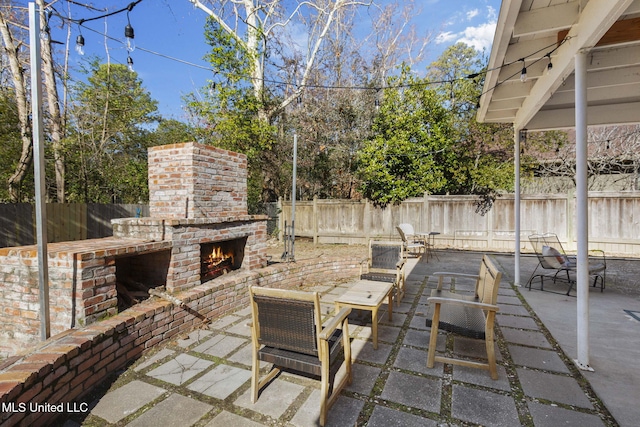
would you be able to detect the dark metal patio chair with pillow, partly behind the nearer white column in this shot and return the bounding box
[527,233,607,295]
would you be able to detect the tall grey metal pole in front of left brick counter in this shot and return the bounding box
[29,3,51,341]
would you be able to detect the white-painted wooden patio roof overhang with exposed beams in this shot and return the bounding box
[477,0,640,130]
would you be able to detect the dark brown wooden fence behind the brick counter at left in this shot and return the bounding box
[0,203,149,247]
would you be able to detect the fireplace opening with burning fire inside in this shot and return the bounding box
[200,237,247,283]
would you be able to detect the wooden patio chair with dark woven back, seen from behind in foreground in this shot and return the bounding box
[249,286,352,426]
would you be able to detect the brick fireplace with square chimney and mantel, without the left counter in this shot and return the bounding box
[112,142,267,292]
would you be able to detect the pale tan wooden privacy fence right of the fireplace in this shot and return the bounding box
[279,192,640,255]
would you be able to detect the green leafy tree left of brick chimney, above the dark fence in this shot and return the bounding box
[66,59,158,203]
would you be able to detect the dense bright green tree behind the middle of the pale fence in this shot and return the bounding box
[358,68,454,205]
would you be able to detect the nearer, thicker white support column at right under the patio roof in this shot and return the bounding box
[575,50,593,371]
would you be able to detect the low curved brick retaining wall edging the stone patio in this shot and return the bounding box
[0,258,360,426]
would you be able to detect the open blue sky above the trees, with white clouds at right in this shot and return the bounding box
[53,0,501,120]
